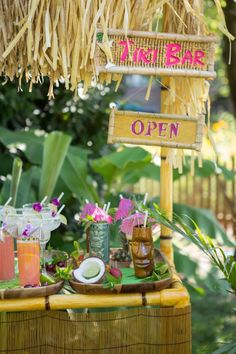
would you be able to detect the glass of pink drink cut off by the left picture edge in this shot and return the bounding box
[0,230,15,281]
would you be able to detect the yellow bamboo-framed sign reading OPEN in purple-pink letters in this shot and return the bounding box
[108,109,205,151]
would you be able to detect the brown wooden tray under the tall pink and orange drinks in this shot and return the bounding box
[0,280,64,301]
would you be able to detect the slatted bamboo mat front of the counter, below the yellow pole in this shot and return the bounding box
[0,306,191,354]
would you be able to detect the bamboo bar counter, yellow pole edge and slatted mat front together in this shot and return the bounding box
[0,268,192,354]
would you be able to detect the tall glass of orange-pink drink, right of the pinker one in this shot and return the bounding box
[17,238,40,286]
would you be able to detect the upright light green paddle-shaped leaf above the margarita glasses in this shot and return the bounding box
[39,132,71,199]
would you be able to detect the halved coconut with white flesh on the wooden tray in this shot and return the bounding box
[73,257,106,284]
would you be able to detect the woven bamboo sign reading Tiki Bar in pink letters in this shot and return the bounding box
[95,29,216,79]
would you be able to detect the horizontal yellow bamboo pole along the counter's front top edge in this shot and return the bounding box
[0,288,189,312]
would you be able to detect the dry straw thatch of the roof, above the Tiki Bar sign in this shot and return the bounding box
[0,0,233,98]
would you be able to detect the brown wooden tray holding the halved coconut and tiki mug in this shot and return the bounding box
[69,249,172,294]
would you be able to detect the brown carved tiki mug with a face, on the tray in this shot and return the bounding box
[131,227,154,278]
